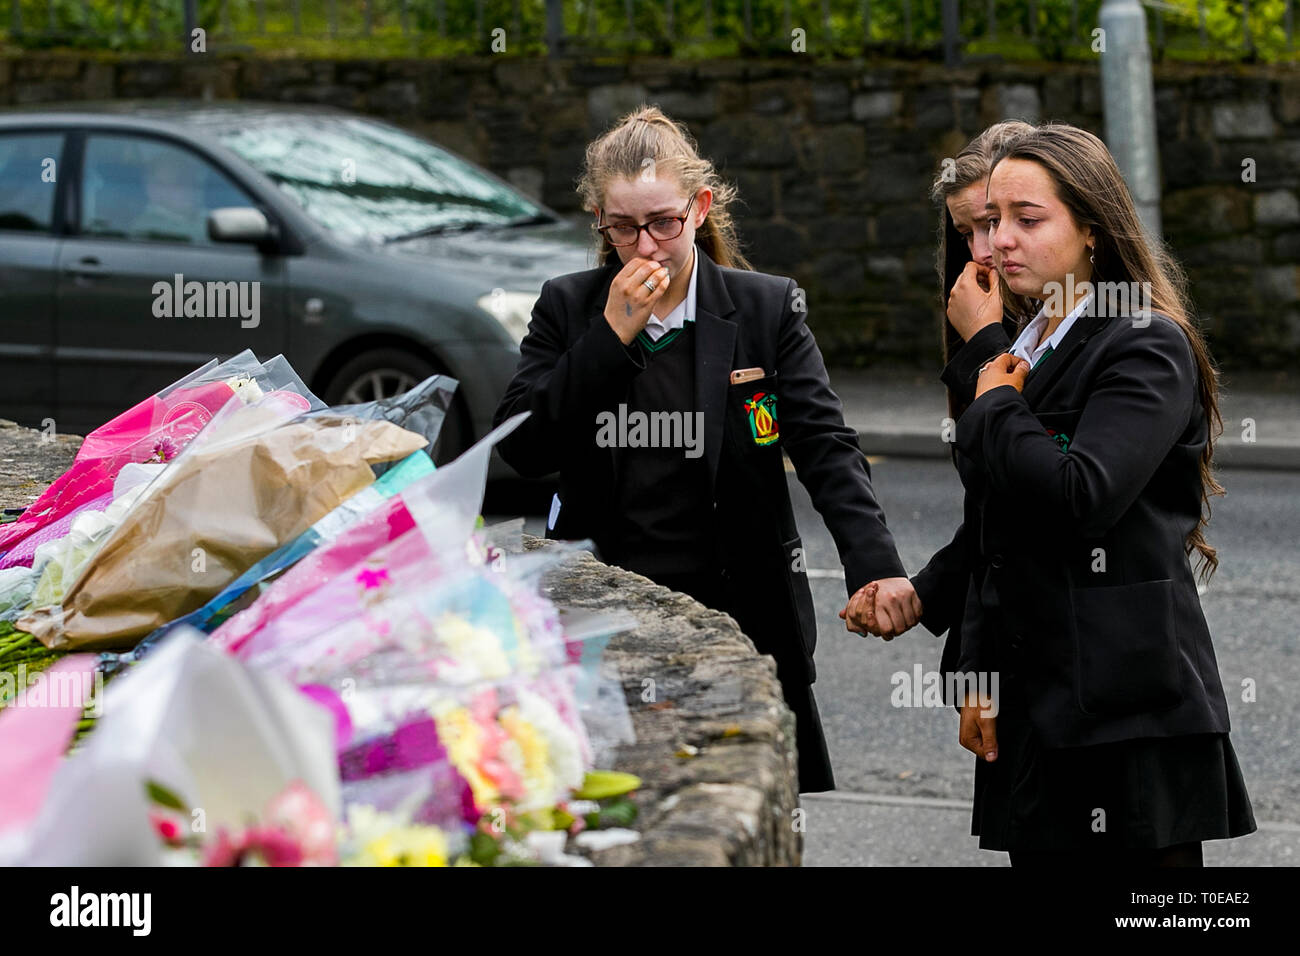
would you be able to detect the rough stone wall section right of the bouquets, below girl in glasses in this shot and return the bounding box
[525,536,803,866]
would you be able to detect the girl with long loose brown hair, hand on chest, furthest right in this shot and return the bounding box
[956,124,1256,865]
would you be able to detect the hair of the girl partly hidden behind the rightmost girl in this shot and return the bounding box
[930,120,1034,419]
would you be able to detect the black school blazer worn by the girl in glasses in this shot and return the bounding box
[494,243,904,682]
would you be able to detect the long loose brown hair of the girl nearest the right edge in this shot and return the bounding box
[989,124,1223,580]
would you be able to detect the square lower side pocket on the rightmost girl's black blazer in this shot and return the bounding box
[1070,580,1183,717]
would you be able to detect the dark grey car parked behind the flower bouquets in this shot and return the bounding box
[0,101,594,476]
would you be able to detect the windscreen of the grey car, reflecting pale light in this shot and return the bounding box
[209,116,550,242]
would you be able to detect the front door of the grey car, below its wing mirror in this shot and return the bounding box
[55,129,286,428]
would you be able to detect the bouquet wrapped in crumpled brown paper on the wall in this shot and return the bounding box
[18,392,425,650]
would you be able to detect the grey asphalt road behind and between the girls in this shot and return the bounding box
[489,458,1300,866]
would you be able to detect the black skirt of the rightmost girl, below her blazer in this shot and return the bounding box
[971,685,1256,853]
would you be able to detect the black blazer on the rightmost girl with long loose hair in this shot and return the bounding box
[919,306,1229,747]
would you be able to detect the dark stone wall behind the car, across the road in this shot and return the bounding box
[0,55,1300,368]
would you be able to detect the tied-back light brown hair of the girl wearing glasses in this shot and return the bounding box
[577,105,754,269]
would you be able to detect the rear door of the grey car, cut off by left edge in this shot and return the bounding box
[0,130,65,427]
